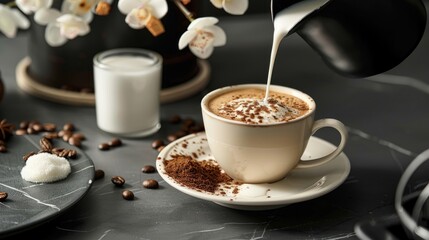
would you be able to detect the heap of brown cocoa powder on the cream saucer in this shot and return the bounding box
[164,155,233,193]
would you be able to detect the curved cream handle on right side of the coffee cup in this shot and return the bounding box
[296,118,348,168]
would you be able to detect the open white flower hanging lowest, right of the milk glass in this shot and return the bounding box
[179,17,226,59]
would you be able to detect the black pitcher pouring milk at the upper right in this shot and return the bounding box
[272,0,427,77]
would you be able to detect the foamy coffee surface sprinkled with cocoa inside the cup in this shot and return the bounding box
[209,89,308,124]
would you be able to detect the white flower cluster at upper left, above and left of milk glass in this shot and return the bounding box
[34,8,90,47]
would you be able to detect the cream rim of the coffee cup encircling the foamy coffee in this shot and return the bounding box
[201,83,316,127]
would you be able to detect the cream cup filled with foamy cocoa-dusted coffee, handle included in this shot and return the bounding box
[201,84,347,183]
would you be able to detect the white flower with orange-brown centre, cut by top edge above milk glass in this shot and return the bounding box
[118,0,168,29]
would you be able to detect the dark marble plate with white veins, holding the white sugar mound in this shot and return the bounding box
[0,135,94,237]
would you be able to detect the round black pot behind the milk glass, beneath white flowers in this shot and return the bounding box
[27,1,199,91]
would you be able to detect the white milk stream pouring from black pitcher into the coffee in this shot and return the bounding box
[264,0,330,103]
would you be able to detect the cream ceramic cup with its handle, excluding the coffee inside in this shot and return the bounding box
[201,84,348,183]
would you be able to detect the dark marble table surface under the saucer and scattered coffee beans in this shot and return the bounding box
[0,5,429,239]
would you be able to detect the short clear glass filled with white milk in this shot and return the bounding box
[93,48,162,137]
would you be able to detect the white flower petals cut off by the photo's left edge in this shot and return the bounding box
[0,4,30,38]
